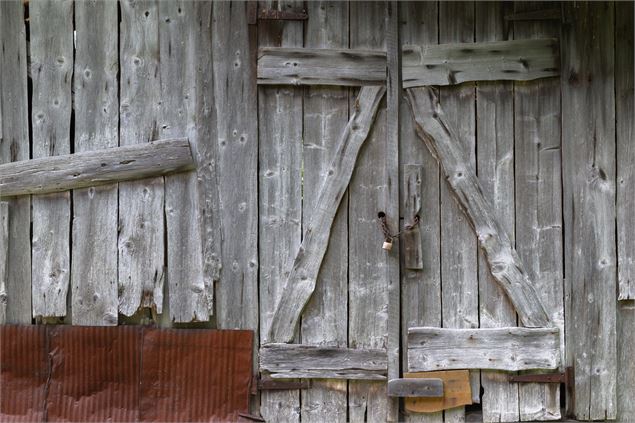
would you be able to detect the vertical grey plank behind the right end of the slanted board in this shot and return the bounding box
[159,2,216,322]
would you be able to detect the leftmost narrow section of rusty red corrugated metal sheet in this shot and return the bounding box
[0,326,49,422]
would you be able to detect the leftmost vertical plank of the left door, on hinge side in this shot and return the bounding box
[258,2,303,422]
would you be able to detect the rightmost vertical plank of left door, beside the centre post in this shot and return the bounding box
[348,2,390,422]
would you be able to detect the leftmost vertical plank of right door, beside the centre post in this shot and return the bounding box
[399,2,443,423]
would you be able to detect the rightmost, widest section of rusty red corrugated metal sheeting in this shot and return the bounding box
[140,329,253,421]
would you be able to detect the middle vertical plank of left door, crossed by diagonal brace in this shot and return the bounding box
[301,1,349,422]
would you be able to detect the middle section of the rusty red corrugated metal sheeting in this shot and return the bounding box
[47,326,142,422]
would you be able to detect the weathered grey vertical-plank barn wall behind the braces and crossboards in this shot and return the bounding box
[0,0,635,422]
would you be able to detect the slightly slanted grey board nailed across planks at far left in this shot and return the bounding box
[0,139,194,197]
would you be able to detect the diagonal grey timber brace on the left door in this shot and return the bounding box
[269,86,386,342]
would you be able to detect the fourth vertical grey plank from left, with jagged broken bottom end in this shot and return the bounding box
[118,0,165,316]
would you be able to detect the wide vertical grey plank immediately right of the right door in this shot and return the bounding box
[561,3,617,420]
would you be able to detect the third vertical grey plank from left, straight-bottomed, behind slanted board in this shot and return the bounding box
[72,1,119,326]
